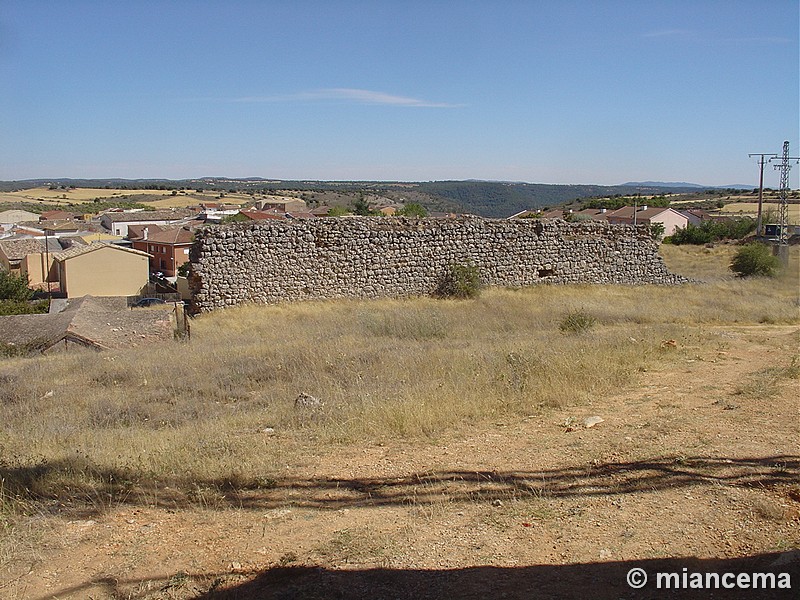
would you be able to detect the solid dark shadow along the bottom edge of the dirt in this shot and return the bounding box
[28,550,800,600]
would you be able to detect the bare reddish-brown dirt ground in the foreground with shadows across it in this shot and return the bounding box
[0,325,800,600]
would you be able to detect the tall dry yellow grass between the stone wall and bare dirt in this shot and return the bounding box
[0,248,799,525]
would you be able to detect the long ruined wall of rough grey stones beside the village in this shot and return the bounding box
[190,217,685,311]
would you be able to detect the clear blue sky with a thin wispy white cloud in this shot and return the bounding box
[0,0,800,187]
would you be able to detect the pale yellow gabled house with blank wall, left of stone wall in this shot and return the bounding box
[53,243,150,298]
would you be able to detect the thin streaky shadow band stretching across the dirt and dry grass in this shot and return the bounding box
[0,455,800,518]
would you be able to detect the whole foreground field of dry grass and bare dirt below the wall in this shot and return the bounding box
[0,246,800,599]
